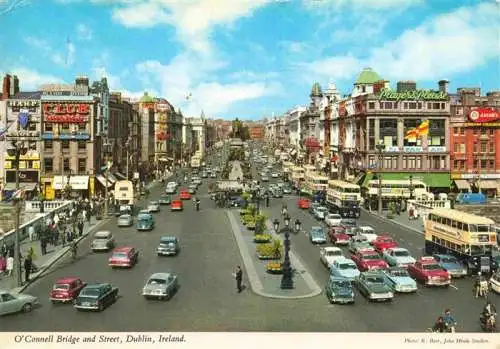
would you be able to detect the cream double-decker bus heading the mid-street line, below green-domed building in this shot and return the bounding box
[326,180,361,218]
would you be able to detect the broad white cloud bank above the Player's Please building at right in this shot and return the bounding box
[302,3,500,80]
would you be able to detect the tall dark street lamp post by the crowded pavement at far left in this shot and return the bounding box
[7,142,28,286]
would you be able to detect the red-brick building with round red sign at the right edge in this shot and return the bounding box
[450,88,500,196]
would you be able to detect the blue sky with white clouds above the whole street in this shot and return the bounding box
[0,0,500,119]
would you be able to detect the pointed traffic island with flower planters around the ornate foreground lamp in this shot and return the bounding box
[226,210,321,299]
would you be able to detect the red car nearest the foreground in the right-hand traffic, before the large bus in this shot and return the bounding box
[408,257,451,286]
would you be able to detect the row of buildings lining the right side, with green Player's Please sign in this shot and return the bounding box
[265,68,500,196]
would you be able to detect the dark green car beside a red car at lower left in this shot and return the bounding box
[73,283,118,311]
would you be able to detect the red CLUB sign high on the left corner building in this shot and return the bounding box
[43,103,90,124]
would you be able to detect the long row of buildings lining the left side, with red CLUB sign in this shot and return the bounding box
[0,75,215,200]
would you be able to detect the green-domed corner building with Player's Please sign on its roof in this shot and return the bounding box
[339,70,450,191]
